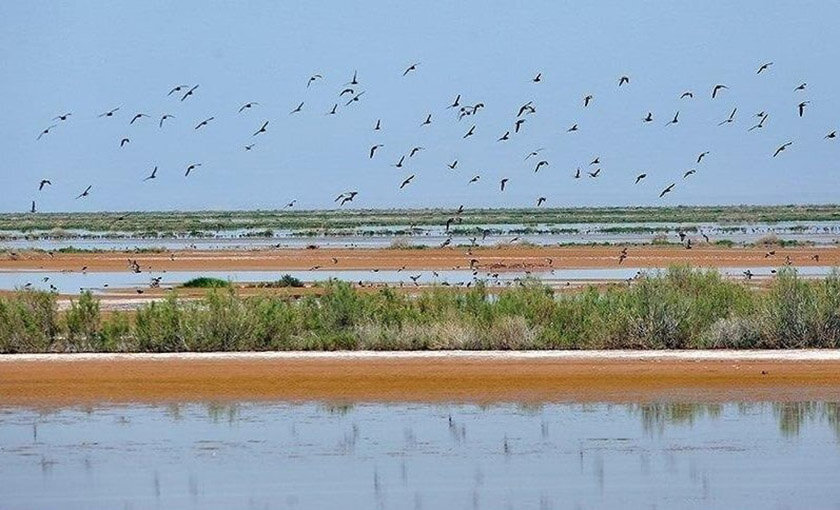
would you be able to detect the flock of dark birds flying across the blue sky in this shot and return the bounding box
[24,62,837,221]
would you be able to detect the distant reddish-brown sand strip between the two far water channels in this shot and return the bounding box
[0,245,840,272]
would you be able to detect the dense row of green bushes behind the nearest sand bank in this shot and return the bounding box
[0,267,840,353]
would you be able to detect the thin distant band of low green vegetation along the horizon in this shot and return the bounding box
[0,205,840,238]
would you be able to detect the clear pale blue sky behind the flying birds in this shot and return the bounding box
[0,0,840,212]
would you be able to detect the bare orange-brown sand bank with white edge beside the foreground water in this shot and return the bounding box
[0,350,840,407]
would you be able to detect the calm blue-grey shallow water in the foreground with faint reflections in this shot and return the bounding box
[0,403,840,509]
